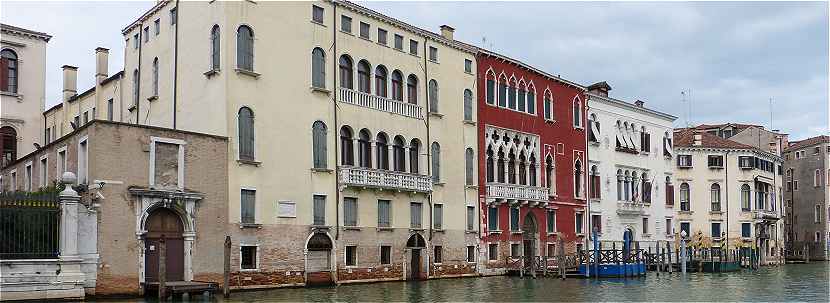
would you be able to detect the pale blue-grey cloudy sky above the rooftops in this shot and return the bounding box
[0,1,830,140]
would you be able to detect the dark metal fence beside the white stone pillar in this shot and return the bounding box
[0,192,61,260]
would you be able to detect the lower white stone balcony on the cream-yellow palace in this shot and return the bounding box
[337,166,432,192]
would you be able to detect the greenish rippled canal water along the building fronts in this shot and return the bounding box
[127,262,830,302]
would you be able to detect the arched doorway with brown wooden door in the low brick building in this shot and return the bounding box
[144,207,184,283]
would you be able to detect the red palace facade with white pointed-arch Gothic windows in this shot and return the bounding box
[477,51,588,273]
